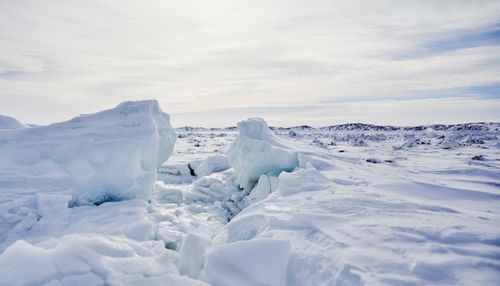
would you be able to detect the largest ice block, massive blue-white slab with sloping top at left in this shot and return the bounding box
[0,101,176,206]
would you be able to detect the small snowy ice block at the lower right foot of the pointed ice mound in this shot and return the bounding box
[278,167,332,196]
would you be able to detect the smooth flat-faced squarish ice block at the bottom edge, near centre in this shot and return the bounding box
[205,239,291,286]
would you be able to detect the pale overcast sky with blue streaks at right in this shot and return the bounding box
[0,0,500,127]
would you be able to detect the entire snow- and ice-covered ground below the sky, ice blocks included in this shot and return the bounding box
[0,102,500,285]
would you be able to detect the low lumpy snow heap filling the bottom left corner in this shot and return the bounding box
[0,235,206,285]
